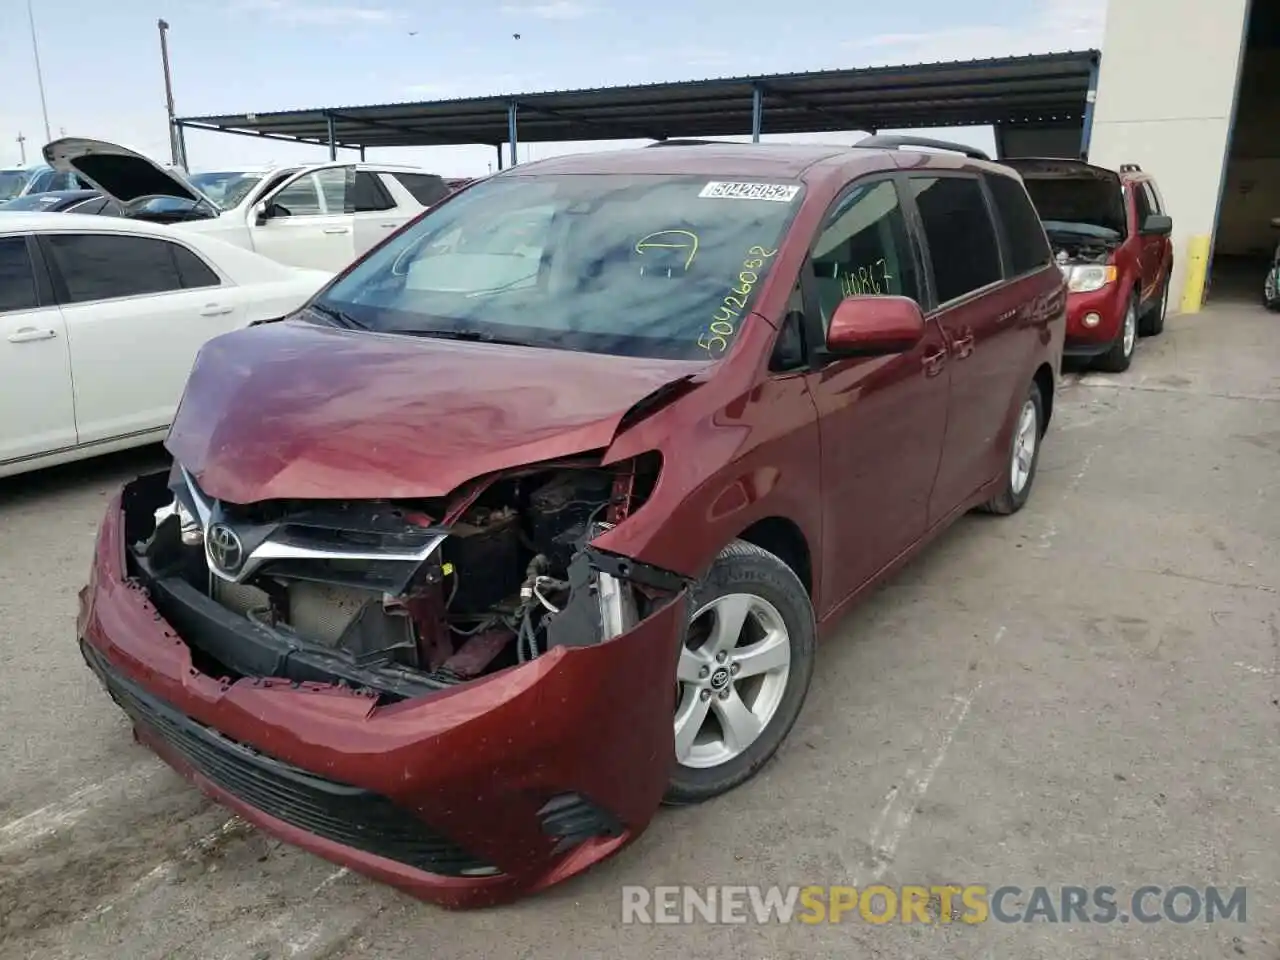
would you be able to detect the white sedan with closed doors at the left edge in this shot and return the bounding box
[0,212,330,476]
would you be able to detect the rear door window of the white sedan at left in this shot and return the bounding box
[45,233,182,303]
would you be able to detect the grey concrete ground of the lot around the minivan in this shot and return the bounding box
[0,305,1280,960]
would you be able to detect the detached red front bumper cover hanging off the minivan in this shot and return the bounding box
[78,488,687,906]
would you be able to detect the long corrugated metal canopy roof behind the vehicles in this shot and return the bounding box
[180,50,1101,147]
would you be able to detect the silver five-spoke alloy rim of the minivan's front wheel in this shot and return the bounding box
[675,594,791,769]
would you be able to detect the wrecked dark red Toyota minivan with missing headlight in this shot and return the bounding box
[78,138,1066,905]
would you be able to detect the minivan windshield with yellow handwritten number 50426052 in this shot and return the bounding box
[316,174,803,360]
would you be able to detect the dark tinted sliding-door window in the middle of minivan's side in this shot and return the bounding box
[911,177,1002,303]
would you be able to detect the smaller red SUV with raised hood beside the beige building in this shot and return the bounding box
[1004,159,1174,372]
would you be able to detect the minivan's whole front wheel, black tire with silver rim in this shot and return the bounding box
[663,540,817,805]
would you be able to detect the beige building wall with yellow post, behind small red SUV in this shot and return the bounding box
[1089,0,1248,305]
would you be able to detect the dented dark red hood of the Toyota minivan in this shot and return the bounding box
[165,321,705,503]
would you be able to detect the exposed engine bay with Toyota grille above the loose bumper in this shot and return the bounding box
[123,454,682,699]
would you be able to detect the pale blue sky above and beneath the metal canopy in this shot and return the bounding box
[0,0,1106,175]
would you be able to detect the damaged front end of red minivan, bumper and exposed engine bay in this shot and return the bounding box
[77,456,689,906]
